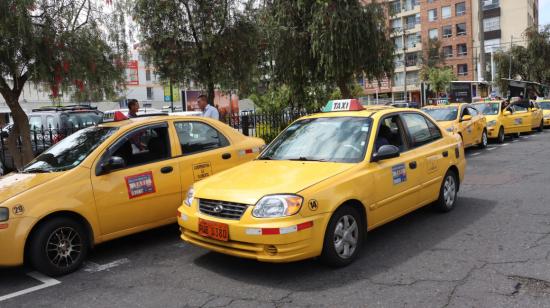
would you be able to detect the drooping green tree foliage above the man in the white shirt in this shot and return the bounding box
[134,0,259,104]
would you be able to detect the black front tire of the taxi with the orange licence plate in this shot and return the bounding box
[321,205,365,267]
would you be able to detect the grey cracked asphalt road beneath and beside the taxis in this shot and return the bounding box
[0,130,550,308]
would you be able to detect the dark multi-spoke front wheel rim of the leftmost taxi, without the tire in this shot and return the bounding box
[46,227,82,268]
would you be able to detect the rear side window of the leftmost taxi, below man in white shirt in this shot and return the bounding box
[174,121,229,155]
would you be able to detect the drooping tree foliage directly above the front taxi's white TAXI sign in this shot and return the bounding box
[265,0,394,107]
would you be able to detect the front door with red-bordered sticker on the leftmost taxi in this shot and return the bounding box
[91,122,182,235]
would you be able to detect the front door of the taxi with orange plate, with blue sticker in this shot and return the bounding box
[369,114,421,226]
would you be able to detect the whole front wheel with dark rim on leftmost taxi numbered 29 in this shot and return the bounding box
[27,217,90,277]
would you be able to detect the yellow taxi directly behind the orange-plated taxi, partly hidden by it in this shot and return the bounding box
[422,103,488,148]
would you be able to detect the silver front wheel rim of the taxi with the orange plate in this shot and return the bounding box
[334,215,359,259]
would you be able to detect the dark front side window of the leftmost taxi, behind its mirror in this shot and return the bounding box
[106,124,172,167]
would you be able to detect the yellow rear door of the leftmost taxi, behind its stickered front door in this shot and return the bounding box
[173,120,242,197]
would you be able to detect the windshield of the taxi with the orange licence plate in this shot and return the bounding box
[259,117,372,163]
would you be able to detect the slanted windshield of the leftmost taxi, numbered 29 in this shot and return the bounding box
[22,127,118,173]
